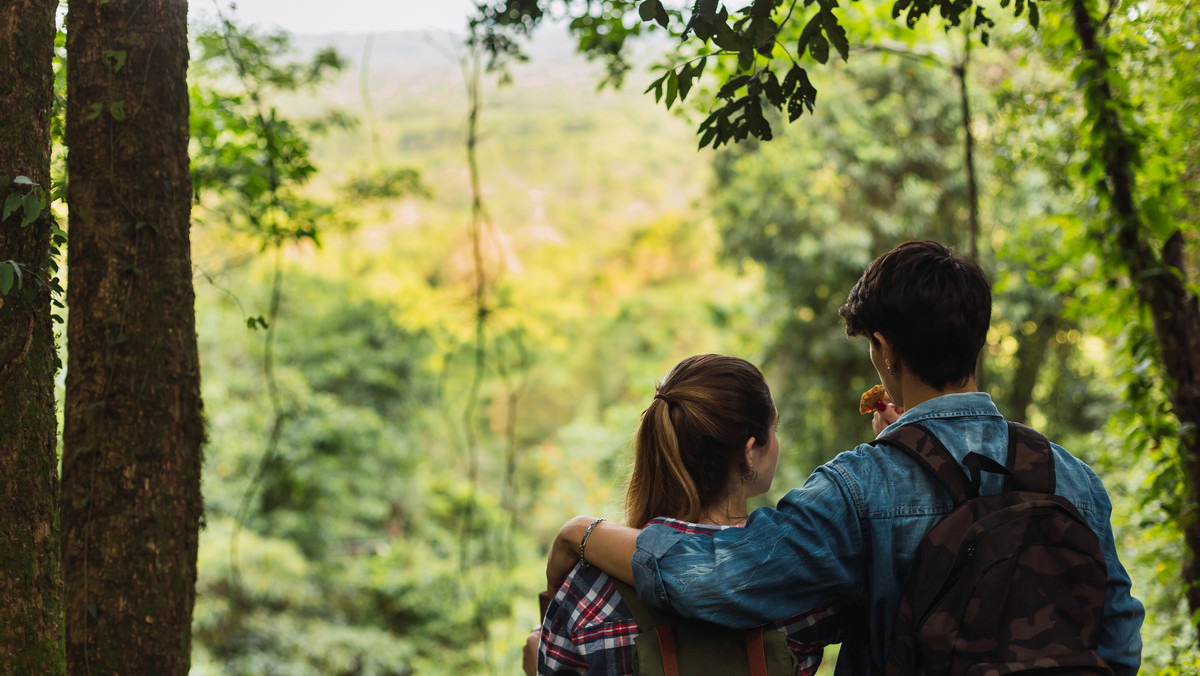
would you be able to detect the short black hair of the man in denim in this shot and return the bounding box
[838,240,991,389]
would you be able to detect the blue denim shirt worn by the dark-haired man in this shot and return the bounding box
[634,393,1145,676]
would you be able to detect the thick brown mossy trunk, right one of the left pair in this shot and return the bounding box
[62,0,204,676]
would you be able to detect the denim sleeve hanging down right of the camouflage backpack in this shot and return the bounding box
[1088,468,1146,676]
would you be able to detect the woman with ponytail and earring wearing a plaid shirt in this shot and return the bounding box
[530,354,833,676]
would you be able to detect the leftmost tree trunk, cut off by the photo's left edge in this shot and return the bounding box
[0,0,64,676]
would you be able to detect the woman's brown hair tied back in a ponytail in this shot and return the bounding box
[625,354,775,528]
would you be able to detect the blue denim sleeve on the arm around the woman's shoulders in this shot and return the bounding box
[634,460,865,628]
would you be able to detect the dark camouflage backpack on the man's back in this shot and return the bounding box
[872,423,1112,676]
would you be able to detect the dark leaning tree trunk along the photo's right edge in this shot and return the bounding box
[1072,0,1200,638]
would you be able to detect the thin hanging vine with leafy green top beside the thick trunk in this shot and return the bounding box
[192,1,344,579]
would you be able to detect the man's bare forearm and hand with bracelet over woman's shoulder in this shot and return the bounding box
[546,516,641,592]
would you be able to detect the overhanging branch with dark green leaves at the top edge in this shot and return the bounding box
[470,0,1039,148]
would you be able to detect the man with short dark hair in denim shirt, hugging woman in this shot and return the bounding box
[546,241,1145,676]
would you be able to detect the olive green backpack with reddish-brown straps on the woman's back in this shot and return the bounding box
[613,579,802,676]
